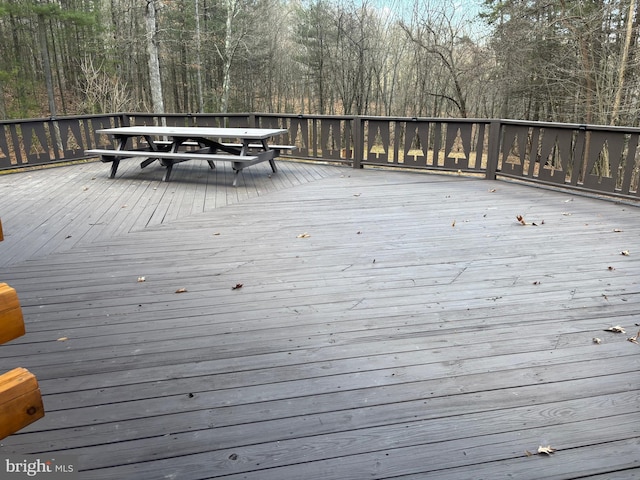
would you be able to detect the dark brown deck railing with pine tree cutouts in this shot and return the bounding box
[0,113,640,199]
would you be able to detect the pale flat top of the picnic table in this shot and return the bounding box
[96,125,288,140]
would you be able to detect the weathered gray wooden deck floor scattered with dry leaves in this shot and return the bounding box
[0,162,640,480]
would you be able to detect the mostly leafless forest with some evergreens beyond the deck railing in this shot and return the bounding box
[0,0,640,126]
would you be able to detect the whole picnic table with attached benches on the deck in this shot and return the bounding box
[85,126,296,186]
